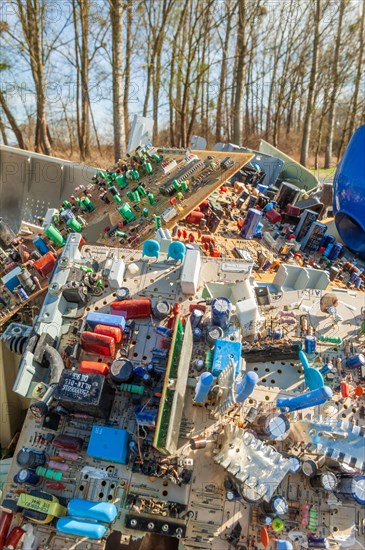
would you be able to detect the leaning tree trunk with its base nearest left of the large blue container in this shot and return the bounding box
[324,0,347,168]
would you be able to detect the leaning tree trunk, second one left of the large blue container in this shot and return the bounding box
[300,0,321,166]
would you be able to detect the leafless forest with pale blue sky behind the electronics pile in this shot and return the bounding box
[0,0,365,168]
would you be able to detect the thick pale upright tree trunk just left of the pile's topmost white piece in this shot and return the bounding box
[110,0,125,162]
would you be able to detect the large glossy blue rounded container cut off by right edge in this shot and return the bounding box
[333,125,365,258]
